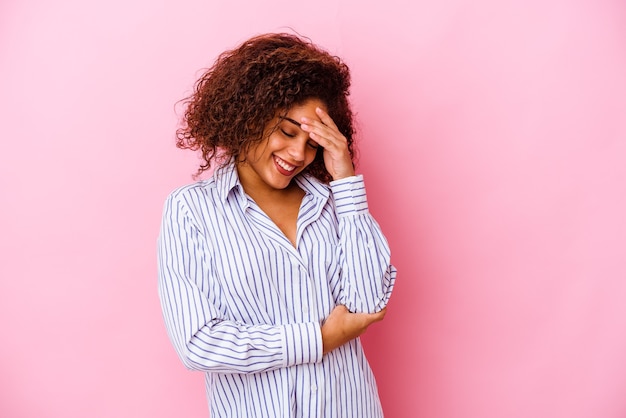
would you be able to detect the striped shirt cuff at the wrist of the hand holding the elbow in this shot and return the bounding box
[282,322,324,367]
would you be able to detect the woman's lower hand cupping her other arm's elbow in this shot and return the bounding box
[322,305,387,354]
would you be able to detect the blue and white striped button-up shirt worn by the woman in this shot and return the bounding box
[158,164,396,418]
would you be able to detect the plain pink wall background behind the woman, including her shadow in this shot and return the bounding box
[0,0,626,418]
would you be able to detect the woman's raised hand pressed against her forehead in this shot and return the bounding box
[300,107,354,180]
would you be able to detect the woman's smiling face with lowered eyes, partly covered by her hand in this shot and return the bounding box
[237,99,326,192]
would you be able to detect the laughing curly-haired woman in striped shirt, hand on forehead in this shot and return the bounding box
[158,34,396,418]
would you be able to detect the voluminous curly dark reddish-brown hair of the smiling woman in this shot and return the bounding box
[176,33,355,183]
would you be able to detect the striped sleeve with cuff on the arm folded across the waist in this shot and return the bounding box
[158,195,323,373]
